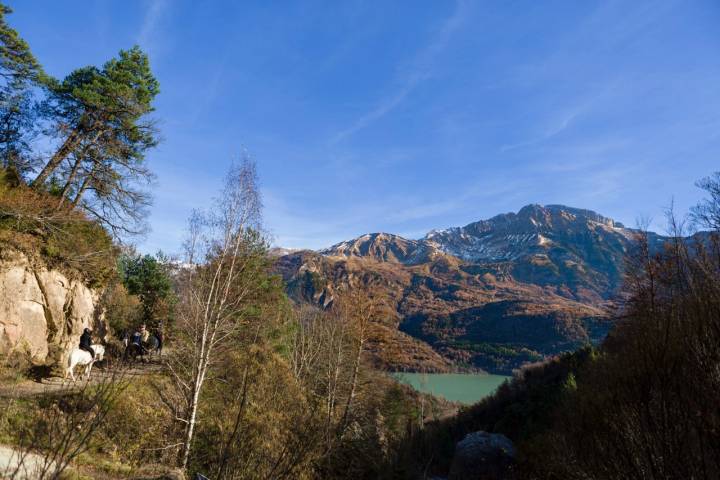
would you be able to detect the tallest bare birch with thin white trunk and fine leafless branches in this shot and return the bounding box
[168,158,266,468]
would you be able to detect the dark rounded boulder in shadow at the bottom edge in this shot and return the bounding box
[448,431,515,480]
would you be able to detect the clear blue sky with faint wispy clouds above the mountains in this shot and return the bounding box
[9,0,720,252]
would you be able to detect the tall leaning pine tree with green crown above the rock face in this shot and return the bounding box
[32,47,159,233]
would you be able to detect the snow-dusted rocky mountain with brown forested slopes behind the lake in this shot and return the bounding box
[276,205,667,373]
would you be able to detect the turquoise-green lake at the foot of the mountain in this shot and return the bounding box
[393,372,511,404]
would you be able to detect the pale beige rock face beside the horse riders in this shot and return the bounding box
[0,251,104,364]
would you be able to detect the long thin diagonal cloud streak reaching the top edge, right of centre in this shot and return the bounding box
[330,0,467,145]
